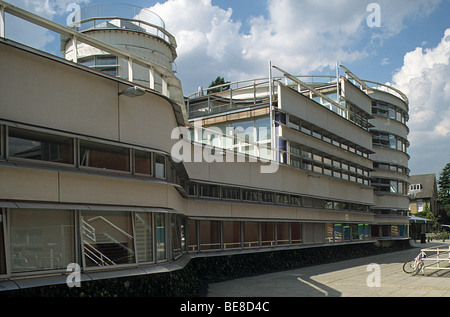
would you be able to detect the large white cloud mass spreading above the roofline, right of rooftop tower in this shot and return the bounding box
[150,0,441,93]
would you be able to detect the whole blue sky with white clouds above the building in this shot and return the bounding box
[6,0,450,174]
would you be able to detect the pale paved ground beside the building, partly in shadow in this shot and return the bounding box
[207,241,450,297]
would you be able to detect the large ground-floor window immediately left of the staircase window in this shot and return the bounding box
[9,209,75,273]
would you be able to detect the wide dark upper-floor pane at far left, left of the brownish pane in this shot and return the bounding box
[8,127,74,164]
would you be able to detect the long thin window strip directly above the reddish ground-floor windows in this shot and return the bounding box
[186,181,370,212]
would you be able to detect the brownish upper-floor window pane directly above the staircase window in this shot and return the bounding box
[80,140,130,172]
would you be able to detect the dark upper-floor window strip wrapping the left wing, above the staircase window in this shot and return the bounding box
[0,126,181,184]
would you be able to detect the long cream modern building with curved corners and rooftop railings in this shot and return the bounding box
[0,1,409,289]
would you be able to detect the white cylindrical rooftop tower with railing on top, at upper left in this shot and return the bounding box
[62,3,177,91]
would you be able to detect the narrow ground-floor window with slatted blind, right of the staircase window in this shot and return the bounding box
[134,212,154,263]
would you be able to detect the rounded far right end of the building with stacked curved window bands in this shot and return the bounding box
[368,87,409,236]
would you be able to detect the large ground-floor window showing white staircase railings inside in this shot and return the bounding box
[81,211,135,266]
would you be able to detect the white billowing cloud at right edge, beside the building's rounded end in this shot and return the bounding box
[393,28,450,172]
